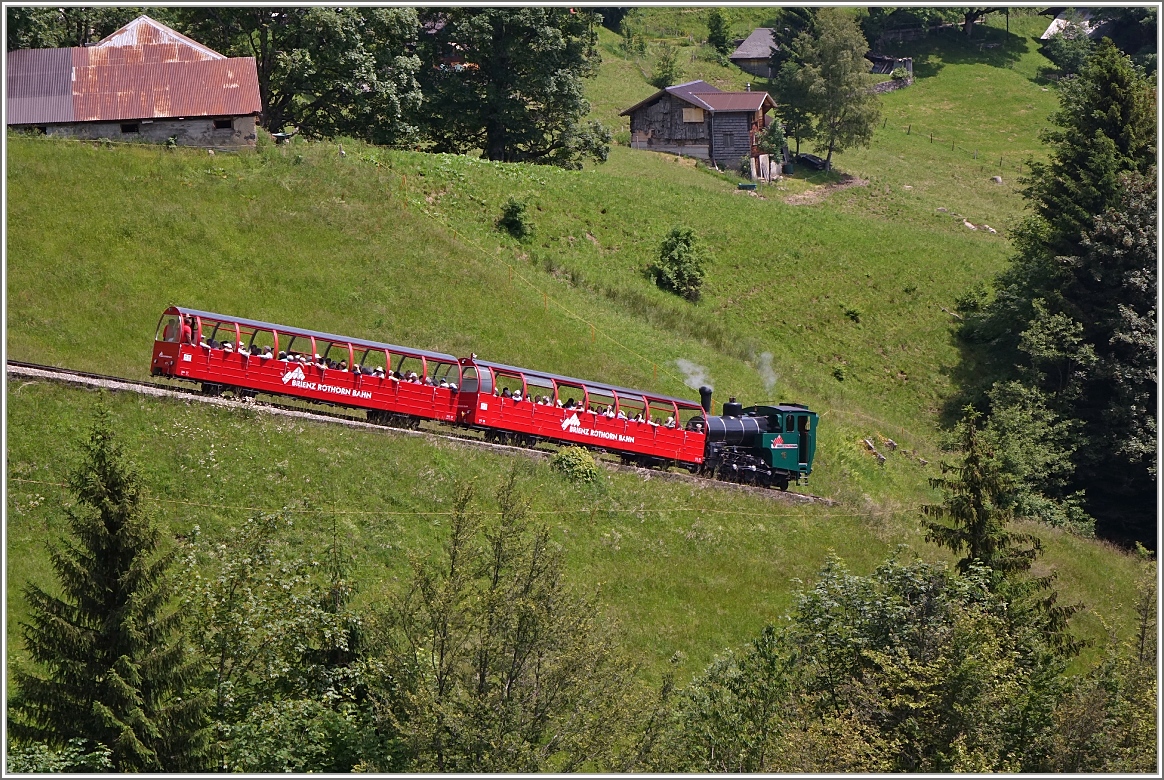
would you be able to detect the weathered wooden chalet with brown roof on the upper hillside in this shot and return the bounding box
[619,81,776,169]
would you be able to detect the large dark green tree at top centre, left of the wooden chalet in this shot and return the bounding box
[420,7,610,168]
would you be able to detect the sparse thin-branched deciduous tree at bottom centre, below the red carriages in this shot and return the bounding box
[375,474,631,773]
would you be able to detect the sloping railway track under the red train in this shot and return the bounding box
[6,360,837,506]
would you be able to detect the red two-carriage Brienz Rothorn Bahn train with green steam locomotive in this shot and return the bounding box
[150,306,818,490]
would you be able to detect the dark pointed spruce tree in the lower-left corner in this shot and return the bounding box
[8,409,205,772]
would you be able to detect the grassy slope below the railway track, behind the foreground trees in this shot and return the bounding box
[7,382,1136,680]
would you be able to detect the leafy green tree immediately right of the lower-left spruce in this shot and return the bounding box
[183,515,370,772]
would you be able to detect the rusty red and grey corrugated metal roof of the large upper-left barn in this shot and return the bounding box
[7,16,262,125]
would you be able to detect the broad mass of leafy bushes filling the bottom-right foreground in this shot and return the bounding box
[648,553,1156,773]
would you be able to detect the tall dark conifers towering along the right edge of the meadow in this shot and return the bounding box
[961,41,1157,545]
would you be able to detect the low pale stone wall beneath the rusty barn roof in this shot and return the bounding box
[13,116,256,149]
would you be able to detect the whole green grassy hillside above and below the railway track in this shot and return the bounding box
[7,9,1135,689]
